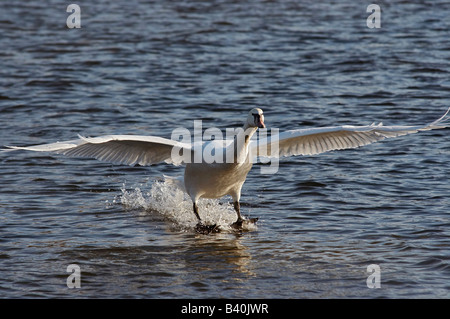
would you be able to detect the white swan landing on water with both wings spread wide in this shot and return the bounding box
[2,108,450,234]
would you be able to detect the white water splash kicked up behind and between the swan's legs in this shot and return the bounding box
[115,178,256,232]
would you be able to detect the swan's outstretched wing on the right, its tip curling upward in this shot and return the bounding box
[251,109,450,157]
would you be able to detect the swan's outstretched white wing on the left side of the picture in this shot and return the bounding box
[6,135,191,165]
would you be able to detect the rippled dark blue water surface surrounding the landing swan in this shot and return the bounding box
[0,0,450,298]
